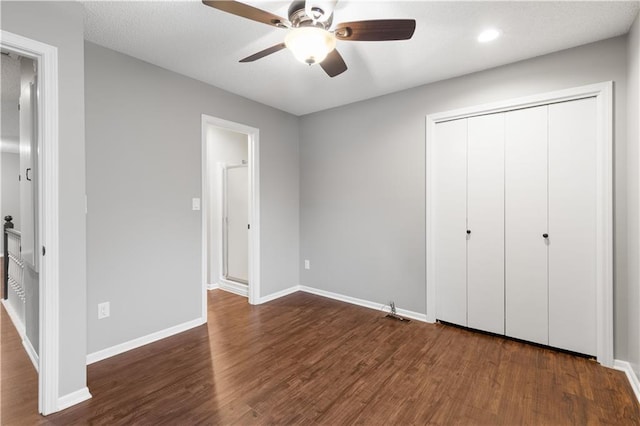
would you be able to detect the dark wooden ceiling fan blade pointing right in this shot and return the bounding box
[335,19,416,41]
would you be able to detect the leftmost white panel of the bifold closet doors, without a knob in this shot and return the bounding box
[432,120,467,325]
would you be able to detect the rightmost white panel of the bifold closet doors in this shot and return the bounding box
[549,98,597,355]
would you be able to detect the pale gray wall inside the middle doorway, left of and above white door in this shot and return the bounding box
[203,126,249,284]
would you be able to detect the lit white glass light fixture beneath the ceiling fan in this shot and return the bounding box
[284,27,336,65]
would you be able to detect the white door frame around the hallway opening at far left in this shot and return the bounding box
[0,31,60,415]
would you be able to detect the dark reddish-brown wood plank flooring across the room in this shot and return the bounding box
[2,290,640,425]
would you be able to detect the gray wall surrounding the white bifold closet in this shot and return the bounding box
[300,37,629,359]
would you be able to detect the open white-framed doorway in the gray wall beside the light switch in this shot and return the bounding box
[202,115,260,315]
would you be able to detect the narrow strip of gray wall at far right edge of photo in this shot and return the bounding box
[623,11,640,374]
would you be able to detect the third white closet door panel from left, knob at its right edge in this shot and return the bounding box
[505,105,549,345]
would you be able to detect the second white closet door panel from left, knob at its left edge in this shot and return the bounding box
[467,114,504,334]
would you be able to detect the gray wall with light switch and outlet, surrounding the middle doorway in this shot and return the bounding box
[85,43,299,353]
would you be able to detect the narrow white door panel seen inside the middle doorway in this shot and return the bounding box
[225,166,249,283]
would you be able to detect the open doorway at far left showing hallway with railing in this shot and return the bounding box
[0,49,40,370]
